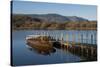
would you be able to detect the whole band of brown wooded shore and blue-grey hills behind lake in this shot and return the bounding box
[12,14,97,30]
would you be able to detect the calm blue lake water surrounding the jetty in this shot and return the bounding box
[12,30,97,65]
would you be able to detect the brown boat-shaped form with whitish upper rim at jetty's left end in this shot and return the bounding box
[26,35,53,53]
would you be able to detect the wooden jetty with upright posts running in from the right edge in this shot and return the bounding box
[26,33,97,61]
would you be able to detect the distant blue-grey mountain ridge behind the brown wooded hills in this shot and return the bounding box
[13,13,89,23]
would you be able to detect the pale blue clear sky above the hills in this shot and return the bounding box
[12,1,97,20]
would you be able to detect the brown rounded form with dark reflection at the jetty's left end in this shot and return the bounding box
[26,36,56,55]
